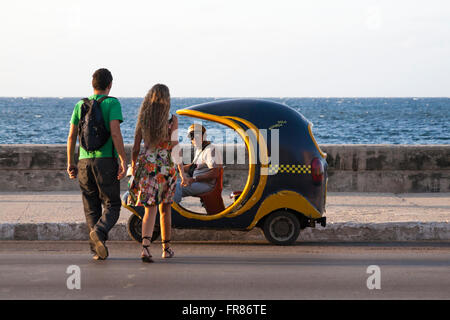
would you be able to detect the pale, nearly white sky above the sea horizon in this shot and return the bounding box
[0,0,450,97]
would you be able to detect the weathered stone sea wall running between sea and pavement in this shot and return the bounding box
[0,144,450,193]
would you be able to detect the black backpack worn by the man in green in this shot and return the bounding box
[78,96,112,151]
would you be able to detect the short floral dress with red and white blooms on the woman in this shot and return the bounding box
[127,119,177,207]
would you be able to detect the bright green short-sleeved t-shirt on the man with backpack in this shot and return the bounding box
[70,94,123,159]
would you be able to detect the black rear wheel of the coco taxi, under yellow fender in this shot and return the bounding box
[263,210,300,246]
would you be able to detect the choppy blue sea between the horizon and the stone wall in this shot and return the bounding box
[0,97,450,145]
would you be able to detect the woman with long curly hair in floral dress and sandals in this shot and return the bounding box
[127,84,185,262]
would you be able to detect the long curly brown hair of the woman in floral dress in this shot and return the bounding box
[136,83,170,148]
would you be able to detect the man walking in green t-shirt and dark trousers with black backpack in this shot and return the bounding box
[67,69,127,260]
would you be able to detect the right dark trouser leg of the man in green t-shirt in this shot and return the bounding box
[94,158,122,241]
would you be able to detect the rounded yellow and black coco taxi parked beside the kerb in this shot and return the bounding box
[122,99,328,245]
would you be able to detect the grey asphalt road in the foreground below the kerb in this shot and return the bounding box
[0,241,450,300]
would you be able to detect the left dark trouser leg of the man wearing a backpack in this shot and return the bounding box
[78,159,102,253]
